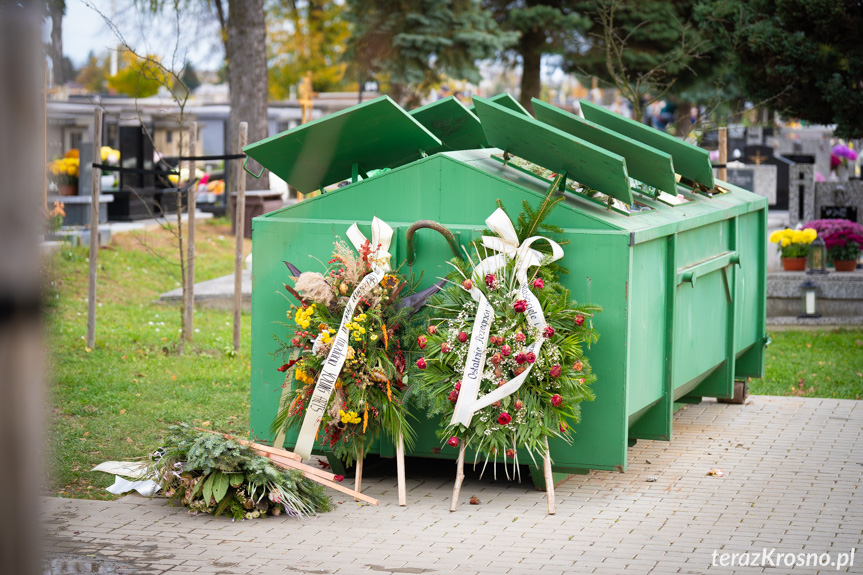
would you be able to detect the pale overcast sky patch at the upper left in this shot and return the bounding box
[58,0,223,69]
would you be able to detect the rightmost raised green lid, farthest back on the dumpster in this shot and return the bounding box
[581,100,714,189]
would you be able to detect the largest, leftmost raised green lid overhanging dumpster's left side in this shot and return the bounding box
[243,96,441,194]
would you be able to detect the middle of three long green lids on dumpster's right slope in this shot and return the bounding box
[532,98,677,195]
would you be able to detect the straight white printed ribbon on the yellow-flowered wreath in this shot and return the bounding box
[294,217,393,459]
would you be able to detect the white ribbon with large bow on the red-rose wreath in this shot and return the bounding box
[450,208,563,426]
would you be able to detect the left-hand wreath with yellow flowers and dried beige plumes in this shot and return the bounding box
[273,224,414,470]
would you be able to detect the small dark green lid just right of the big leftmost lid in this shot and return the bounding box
[410,96,488,154]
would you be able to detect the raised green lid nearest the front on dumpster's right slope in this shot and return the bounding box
[473,97,632,204]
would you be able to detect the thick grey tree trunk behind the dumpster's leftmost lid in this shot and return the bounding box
[225,0,270,191]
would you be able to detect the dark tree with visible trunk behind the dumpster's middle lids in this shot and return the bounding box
[483,0,590,112]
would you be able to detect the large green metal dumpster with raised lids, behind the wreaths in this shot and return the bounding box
[245,96,767,480]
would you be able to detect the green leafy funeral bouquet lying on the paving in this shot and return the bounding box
[152,426,333,520]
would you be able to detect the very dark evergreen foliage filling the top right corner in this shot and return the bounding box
[703,0,863,138]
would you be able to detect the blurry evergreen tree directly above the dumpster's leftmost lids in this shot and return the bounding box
[345,0,517,106]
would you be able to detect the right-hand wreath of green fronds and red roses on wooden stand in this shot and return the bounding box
[416,198,601,469]
